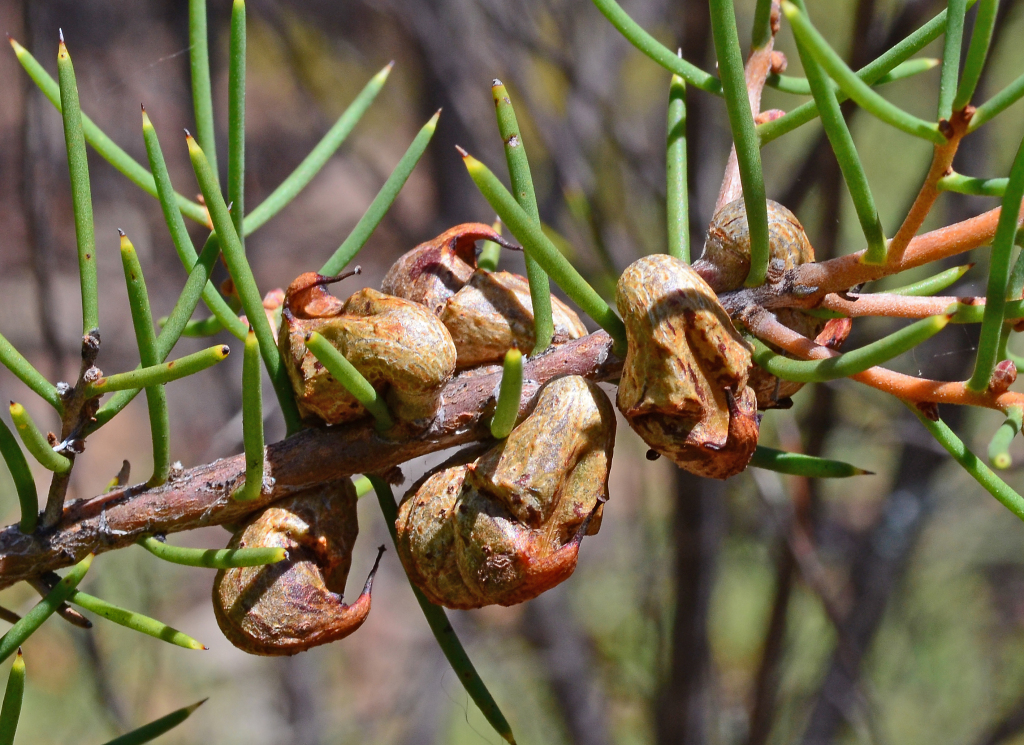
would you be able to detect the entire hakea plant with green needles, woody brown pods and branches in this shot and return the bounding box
[0,0,1024,742]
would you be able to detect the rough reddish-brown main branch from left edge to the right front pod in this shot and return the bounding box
[0,332,622,588]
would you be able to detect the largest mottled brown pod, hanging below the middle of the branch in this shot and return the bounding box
[395,376,615,608]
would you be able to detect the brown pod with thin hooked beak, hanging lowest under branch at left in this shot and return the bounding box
[213,479,384,655]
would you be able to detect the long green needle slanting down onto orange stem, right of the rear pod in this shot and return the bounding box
[794,0,888,265]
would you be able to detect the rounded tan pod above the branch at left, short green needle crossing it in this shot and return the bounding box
[278,272,456,427]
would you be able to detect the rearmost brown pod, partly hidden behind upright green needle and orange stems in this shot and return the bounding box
[693,199,843,409]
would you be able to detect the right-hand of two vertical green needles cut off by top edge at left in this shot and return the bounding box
[227,0,246,247]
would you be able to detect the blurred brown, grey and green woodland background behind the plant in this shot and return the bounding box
[0,0,1024,745]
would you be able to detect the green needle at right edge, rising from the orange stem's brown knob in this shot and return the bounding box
[967,134,1024,391]
